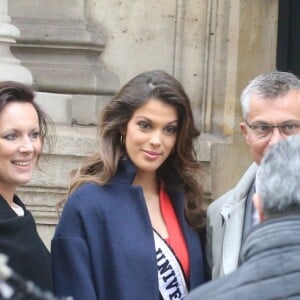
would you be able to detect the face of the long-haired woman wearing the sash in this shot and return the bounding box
[125,98,178,176]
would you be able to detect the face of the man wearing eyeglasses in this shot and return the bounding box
[240,90,300,164]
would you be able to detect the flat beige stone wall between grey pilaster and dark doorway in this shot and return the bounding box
[93,0,278,200]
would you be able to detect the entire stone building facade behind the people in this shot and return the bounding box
[0,0,278,246]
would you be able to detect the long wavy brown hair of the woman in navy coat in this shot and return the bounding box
[61,70,205,229]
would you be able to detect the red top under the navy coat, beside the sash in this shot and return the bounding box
[159,185,190,278]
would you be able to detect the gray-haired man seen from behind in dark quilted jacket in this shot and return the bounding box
[189,135,300,300]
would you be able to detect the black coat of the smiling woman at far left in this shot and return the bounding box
[0,195,52,291]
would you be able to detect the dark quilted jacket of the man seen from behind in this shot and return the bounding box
[186,215,300,300]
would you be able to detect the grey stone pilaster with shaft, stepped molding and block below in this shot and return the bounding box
[8,0,119,125]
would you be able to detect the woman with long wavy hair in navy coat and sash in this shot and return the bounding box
[52,71,205,300]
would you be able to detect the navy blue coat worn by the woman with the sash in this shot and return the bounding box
[51,160,204,300]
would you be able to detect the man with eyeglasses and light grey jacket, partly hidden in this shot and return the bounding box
[206,71,300,279]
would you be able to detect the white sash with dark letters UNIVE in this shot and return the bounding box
[153,230,188,300]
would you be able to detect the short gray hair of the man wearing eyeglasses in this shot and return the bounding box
[240,71,300,119]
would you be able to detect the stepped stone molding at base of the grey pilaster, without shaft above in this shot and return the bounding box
[12,18,119,95]
